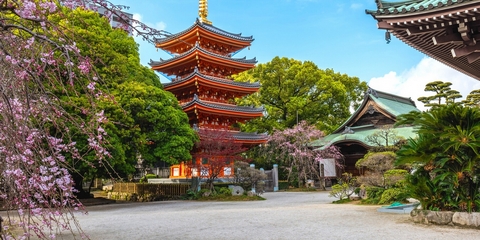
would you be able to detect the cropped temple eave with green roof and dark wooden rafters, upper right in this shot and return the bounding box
[366,0,480,80]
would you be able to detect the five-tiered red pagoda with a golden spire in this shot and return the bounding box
[150,0,267,178]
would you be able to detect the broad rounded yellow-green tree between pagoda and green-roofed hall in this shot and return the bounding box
[234,57,367,132]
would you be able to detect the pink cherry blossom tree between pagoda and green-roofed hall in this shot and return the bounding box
[262,121,343,186]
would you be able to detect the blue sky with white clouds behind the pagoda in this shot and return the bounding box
[112,0,480,110]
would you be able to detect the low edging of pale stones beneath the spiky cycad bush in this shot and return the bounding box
[410,209,480,229]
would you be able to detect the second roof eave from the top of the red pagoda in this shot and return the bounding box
[149,44,257,70]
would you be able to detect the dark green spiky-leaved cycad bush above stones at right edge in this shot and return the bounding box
[396,104,480,212]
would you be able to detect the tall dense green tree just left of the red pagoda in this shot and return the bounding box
[52,8,197,193]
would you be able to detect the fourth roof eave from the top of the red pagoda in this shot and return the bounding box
[182,95,264,118]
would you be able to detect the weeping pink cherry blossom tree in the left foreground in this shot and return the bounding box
[0,0,160,239]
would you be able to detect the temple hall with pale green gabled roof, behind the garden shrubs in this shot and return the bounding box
[311,88,420,177]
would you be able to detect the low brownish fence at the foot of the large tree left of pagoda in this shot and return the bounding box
[109,183,190,202]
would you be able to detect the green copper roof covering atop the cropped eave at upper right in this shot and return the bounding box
[366,0,470,15]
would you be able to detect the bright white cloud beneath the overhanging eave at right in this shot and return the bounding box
[368,57,480,110]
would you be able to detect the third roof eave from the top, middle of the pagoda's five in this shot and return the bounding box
[163,69,260,93]
